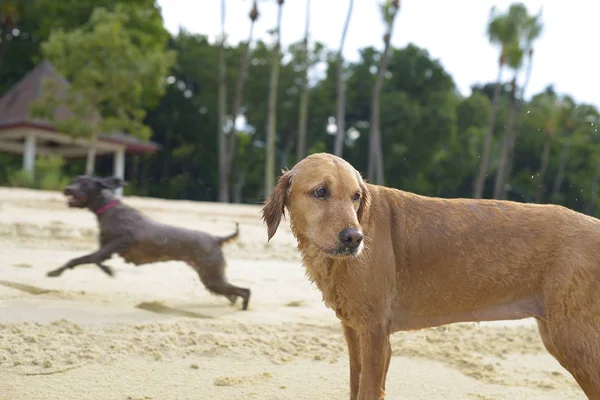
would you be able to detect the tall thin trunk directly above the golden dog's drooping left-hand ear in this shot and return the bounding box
[264,0,284,197]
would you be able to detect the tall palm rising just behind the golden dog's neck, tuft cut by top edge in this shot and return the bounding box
[367,0,400,185]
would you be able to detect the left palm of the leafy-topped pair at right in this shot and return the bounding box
[473,7,517,199]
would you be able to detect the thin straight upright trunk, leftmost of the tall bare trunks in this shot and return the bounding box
[217,0,229,203]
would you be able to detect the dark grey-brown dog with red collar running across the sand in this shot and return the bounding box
[47,175,250,310]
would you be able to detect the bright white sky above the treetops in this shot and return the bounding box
[158,0,600,108]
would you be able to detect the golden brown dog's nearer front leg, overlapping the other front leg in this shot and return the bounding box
[357,324,390,400]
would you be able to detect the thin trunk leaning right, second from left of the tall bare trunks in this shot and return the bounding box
[223,0,259,202]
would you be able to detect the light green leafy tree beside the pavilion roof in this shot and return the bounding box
[32,6,174,174]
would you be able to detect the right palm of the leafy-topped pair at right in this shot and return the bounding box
[494,10,543,199]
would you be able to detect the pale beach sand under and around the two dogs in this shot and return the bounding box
[0,188,585,400]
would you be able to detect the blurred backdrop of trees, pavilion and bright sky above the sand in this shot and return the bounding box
[0,0,600,215]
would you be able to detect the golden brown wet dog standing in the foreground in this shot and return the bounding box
[263,153,600,400]
